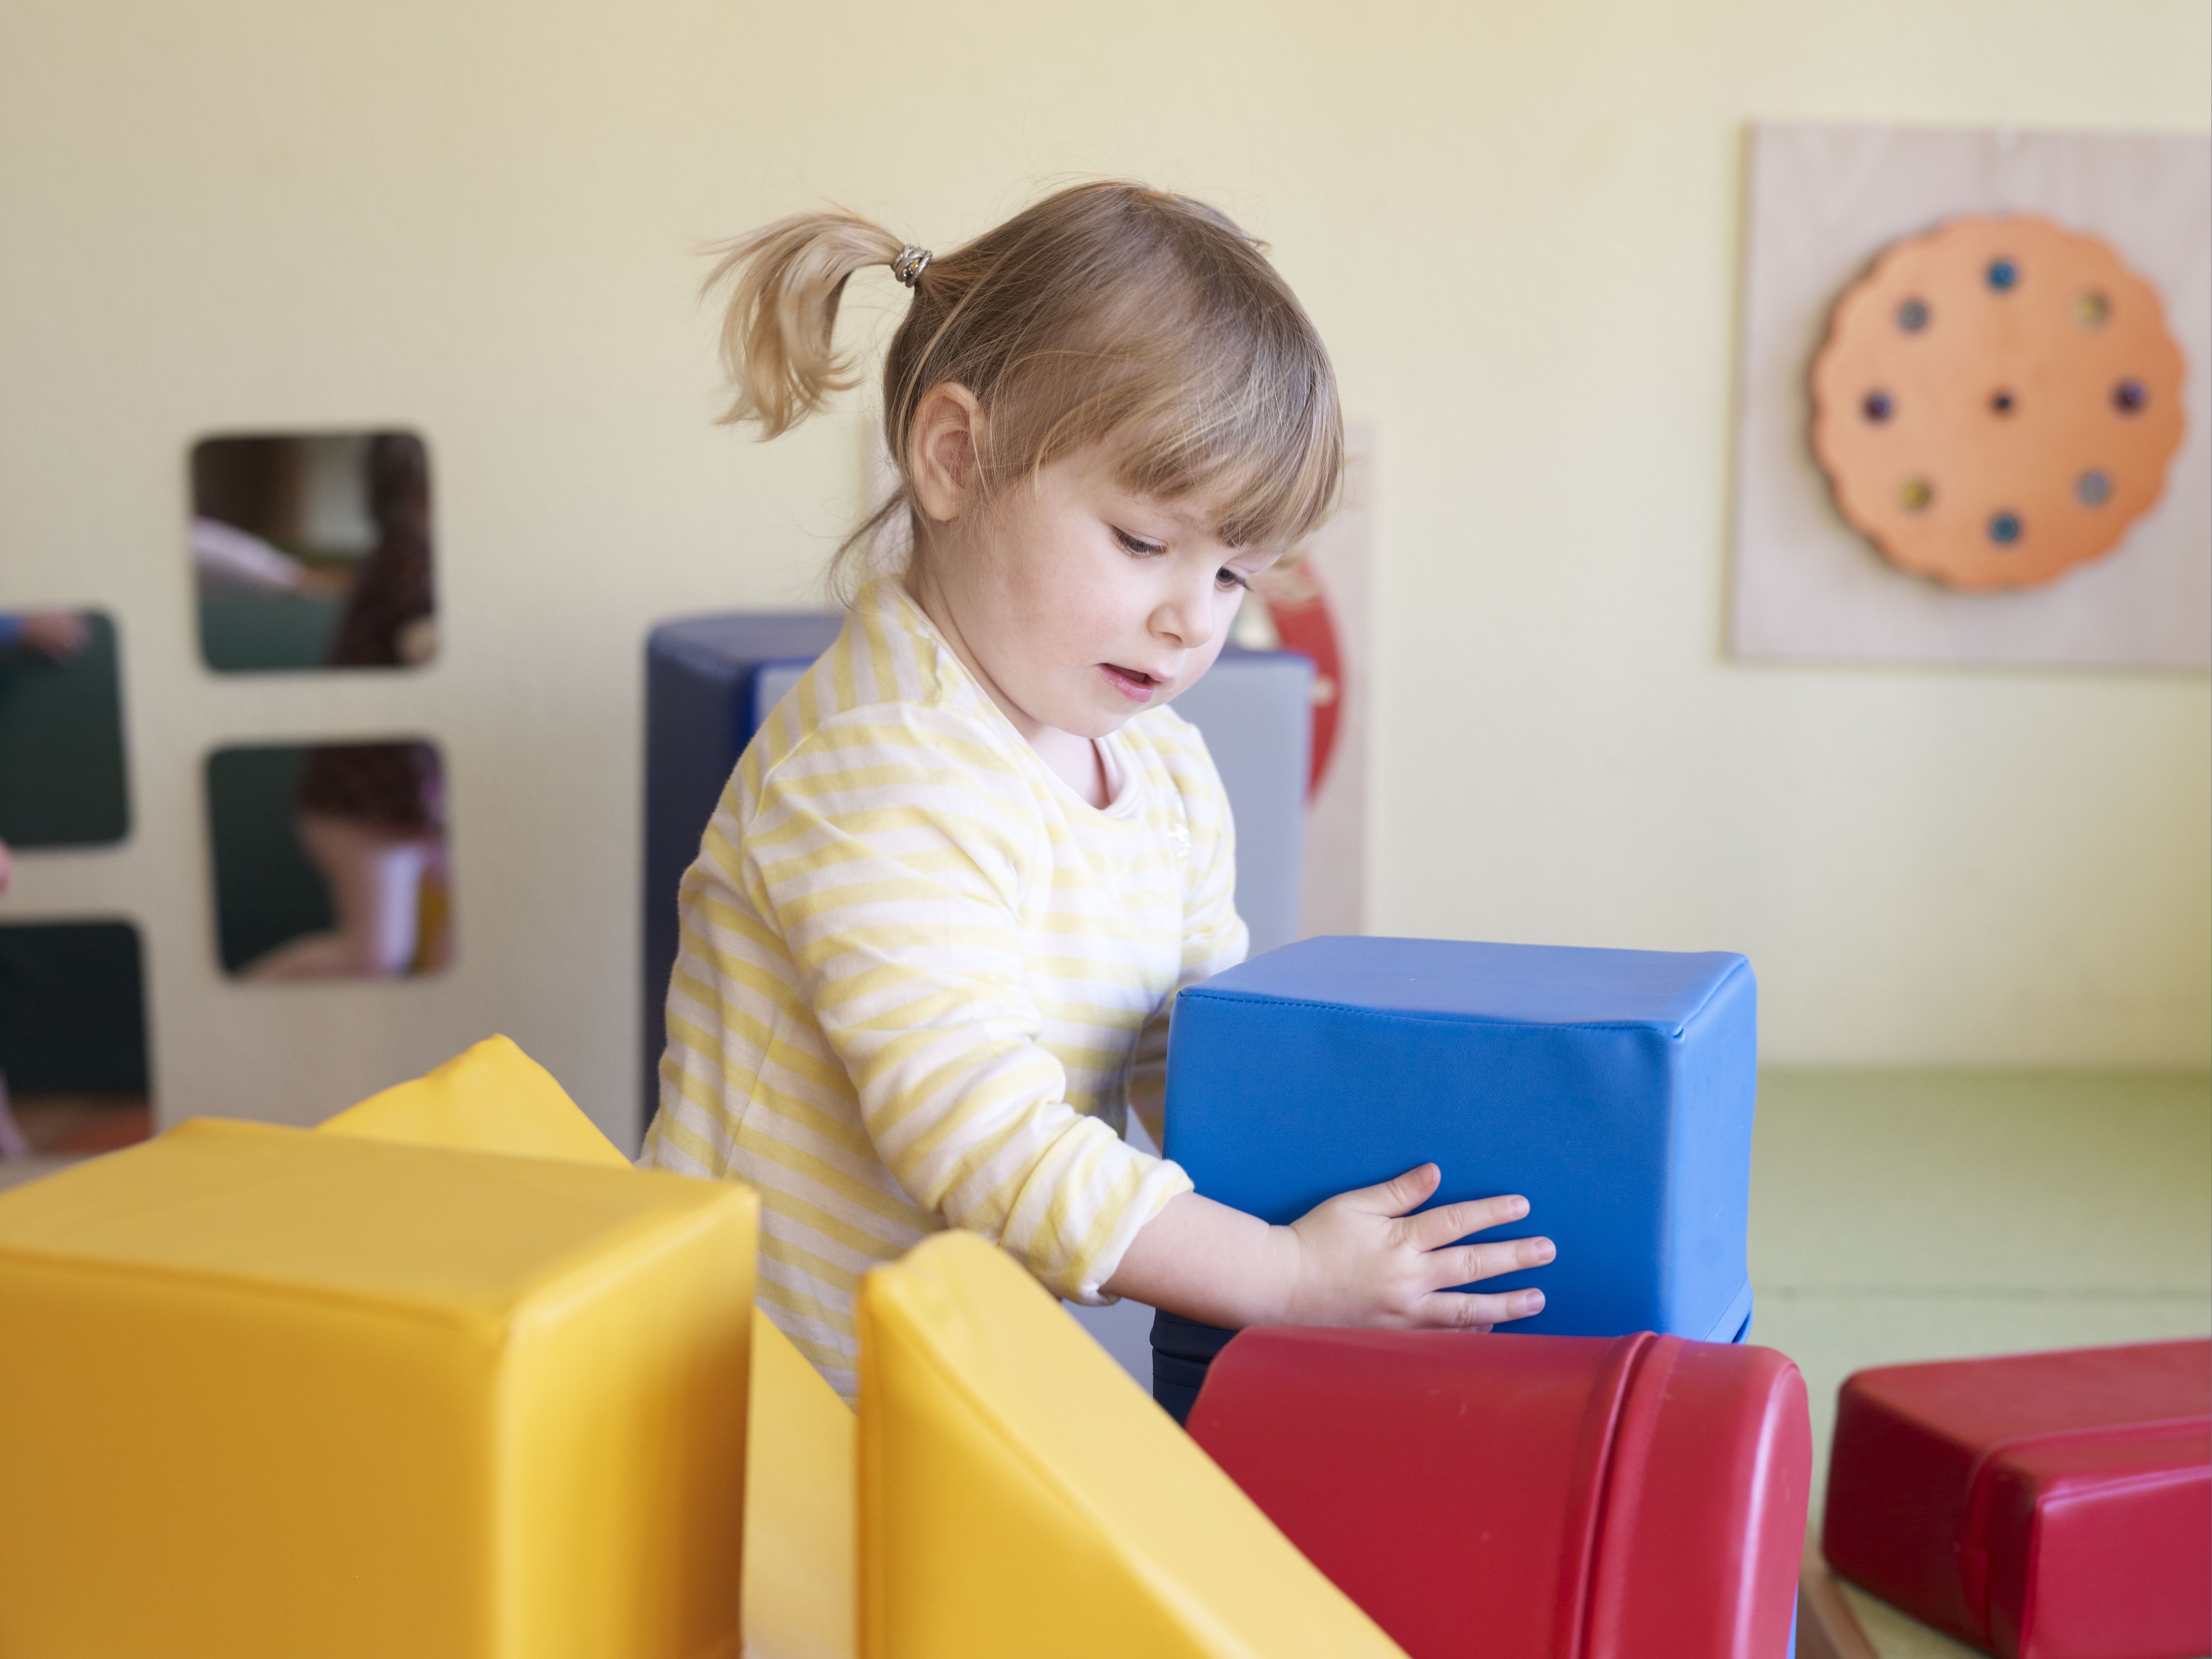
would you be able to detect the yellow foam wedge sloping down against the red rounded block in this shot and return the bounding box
[858,1232,1402,1659]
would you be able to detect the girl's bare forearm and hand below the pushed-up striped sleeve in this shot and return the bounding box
[1104,1164,1555,1329]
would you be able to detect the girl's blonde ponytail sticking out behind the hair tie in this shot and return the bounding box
[699,212,905,438]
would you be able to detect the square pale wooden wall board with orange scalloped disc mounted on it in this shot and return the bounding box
[1725,122,2212,675]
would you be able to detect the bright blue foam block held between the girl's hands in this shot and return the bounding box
[1166,938,1759,1343]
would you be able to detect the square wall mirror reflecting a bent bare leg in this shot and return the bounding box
[208,741,453,980]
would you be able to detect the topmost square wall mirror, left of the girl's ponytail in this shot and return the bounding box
[190,442,436,675]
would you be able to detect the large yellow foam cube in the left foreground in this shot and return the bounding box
[0,1121,757,1659]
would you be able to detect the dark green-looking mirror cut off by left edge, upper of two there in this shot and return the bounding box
[0,611,131,849]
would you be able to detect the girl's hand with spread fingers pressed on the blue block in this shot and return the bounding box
[1274,1164,1557,1332]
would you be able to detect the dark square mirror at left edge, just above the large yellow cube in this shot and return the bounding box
[0,916,153,1186]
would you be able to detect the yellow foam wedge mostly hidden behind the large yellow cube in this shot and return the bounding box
[323,1037,854,1659]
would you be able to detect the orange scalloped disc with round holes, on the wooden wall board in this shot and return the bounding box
[1812,217,2183,588]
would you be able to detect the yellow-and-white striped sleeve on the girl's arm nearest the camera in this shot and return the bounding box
[743,703,1190,1303]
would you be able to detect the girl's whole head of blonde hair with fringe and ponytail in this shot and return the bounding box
[703,179,1345,597]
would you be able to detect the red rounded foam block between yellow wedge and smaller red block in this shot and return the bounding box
[1190,1329,1812,1659]
